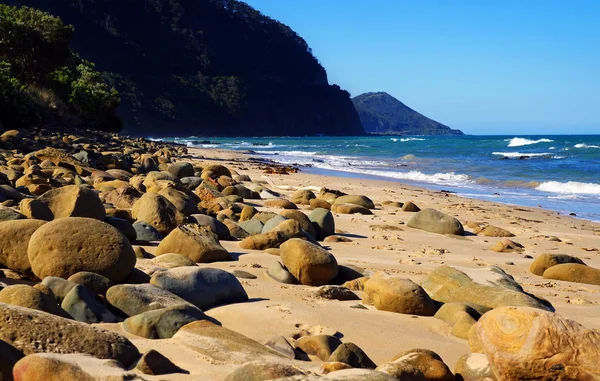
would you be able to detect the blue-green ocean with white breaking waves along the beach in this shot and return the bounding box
[162,135,600,222]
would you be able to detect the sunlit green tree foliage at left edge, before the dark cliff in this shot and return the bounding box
[0,4,121,130]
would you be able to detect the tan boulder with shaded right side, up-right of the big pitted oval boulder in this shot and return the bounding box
[132,193,185,235]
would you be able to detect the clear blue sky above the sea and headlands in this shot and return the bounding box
[246,0,600,134]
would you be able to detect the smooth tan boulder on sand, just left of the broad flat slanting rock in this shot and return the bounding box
[363,273,437,316]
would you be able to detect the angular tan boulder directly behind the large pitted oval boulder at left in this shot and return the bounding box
[38,185,106,221]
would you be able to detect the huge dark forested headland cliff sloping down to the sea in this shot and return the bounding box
[9,0,364,136]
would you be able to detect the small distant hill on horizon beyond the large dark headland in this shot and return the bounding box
[352,92,464,135]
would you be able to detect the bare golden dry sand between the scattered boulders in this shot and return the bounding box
[102,145,600,380]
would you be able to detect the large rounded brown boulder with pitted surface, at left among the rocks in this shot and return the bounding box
[27,217,136,283]
